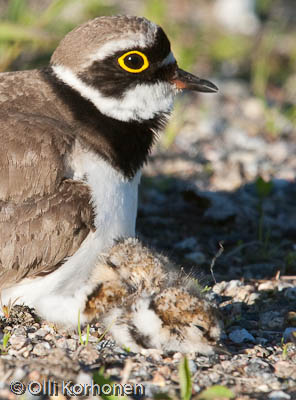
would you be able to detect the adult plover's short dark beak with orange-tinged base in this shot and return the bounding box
[171,68,218,93]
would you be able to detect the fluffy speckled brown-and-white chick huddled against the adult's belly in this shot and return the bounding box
[84,238,222,354]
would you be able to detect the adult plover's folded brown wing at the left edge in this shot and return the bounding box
[0,111,93,288]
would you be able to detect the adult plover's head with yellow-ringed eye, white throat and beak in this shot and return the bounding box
[51,16,217,122]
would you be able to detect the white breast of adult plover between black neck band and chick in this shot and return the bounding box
[68,143,141,249]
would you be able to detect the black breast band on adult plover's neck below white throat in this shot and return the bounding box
[41,68,167,179]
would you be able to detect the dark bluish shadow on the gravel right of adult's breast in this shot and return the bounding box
[137,174,296,284]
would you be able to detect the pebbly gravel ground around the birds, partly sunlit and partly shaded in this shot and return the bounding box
[0,81,296,400]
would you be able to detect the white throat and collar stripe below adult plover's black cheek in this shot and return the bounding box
[52,65,175,122]
